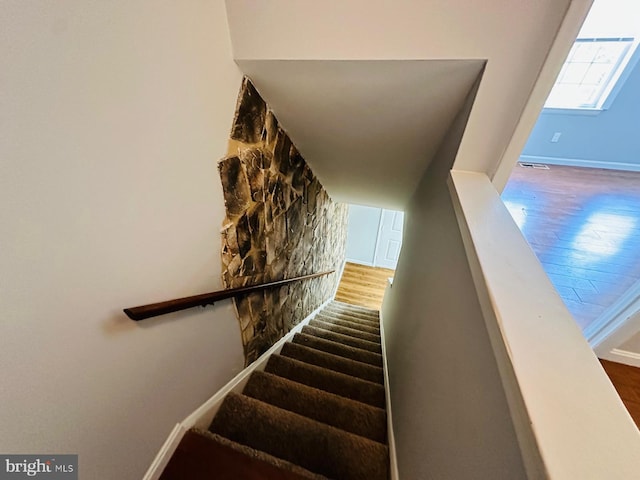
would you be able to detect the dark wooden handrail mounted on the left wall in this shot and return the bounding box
[124,270,335,321]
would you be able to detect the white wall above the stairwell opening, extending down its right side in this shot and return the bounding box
[227,0,580,198]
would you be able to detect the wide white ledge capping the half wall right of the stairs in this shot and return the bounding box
[450,171,640,480]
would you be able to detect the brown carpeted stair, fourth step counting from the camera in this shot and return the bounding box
[264,354,385,408]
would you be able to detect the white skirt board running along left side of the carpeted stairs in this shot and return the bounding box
[143,297,333,480]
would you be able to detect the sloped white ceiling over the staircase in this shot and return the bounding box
[238,60,484,209]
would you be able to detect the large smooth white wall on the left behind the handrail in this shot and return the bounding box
[0,0,243,480]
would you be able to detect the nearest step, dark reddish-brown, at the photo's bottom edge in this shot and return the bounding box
[160,430,327,480]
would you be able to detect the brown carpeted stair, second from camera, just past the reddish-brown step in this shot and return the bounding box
[209,393,389,480]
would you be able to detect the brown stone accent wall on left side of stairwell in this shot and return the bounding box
[218,77,347,365]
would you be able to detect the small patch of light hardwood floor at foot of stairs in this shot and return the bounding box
[336,262,395,310]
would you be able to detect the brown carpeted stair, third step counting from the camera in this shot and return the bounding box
[242,371,387,443]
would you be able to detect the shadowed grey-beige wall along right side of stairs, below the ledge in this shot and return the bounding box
[383,77,526,480]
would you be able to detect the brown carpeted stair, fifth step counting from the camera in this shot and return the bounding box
[280,342,384,385]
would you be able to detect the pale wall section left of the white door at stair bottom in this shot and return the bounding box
[345,205,382,265]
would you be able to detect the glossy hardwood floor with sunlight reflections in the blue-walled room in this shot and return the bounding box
[502,165,640,329]
